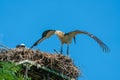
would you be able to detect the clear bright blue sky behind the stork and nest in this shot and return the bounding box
[0,0,120,80]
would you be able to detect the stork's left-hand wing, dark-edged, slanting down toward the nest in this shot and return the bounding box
[30,30,55,49]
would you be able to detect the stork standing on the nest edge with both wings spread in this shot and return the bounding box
[30,30,109,55]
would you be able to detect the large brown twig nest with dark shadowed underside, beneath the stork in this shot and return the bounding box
[0,48,80,80]
